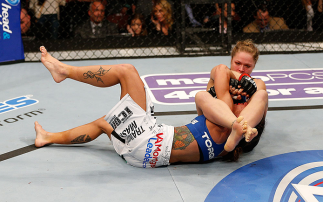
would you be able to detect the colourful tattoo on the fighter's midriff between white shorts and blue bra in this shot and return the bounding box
[173,126,195,150]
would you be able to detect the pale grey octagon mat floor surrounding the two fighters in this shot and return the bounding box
[0,53,323,202]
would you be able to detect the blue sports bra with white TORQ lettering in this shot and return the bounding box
[186,115,225,162]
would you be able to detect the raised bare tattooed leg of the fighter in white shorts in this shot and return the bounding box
[40,46,146,110]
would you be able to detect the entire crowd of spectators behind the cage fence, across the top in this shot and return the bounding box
[21,0,323,39]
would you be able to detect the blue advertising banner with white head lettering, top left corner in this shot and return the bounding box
[0,0,25,63]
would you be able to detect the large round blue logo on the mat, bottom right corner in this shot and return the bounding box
[205,150,323,202]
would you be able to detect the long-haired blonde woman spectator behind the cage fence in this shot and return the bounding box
[151,0,174,36]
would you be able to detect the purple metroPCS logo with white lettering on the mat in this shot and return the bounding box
[142,69,323,105]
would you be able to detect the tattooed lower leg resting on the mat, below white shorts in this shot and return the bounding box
[35,117,113,147]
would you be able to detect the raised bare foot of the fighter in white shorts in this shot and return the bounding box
[39,46,68,83]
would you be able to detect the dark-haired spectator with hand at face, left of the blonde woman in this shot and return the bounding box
[127,13,147,36]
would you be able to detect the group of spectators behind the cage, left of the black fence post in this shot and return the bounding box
[21,0,175,39]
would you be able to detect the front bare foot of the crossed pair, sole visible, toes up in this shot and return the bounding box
[224,116,248,152]
